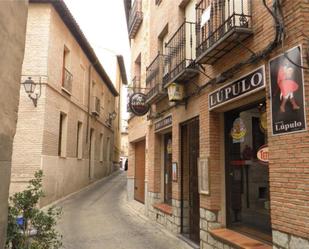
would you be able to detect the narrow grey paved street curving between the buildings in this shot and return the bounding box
[54,172,191,249]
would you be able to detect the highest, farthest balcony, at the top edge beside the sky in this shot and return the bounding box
[129,0,143,39]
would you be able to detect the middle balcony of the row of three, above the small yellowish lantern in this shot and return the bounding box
[163,22,198,86]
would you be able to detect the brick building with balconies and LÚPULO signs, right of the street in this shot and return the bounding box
[124,0,309,249]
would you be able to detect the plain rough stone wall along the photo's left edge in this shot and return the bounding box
[0,1,28,248]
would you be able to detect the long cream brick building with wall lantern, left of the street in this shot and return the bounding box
[11,0,123,206]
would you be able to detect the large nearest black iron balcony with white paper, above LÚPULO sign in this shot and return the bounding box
[196,0,252,64]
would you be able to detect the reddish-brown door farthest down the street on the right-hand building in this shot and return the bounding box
[134,140,146,203]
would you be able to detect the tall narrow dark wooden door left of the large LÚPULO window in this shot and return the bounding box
[188,119,200,243]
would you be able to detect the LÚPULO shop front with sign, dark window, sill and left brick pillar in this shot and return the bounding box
[198,66,272,248]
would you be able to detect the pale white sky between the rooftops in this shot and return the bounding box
[64,0,131,121]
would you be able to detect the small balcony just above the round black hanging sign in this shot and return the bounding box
[145,54,167,104]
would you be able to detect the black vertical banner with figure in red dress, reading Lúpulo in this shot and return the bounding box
[269,46,306,135]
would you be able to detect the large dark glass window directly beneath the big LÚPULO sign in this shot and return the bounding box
[224,101,271,242]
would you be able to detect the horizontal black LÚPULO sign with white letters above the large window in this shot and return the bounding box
[208,66,265,110]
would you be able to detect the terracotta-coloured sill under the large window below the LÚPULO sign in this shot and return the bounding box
[209,228,272,249]
